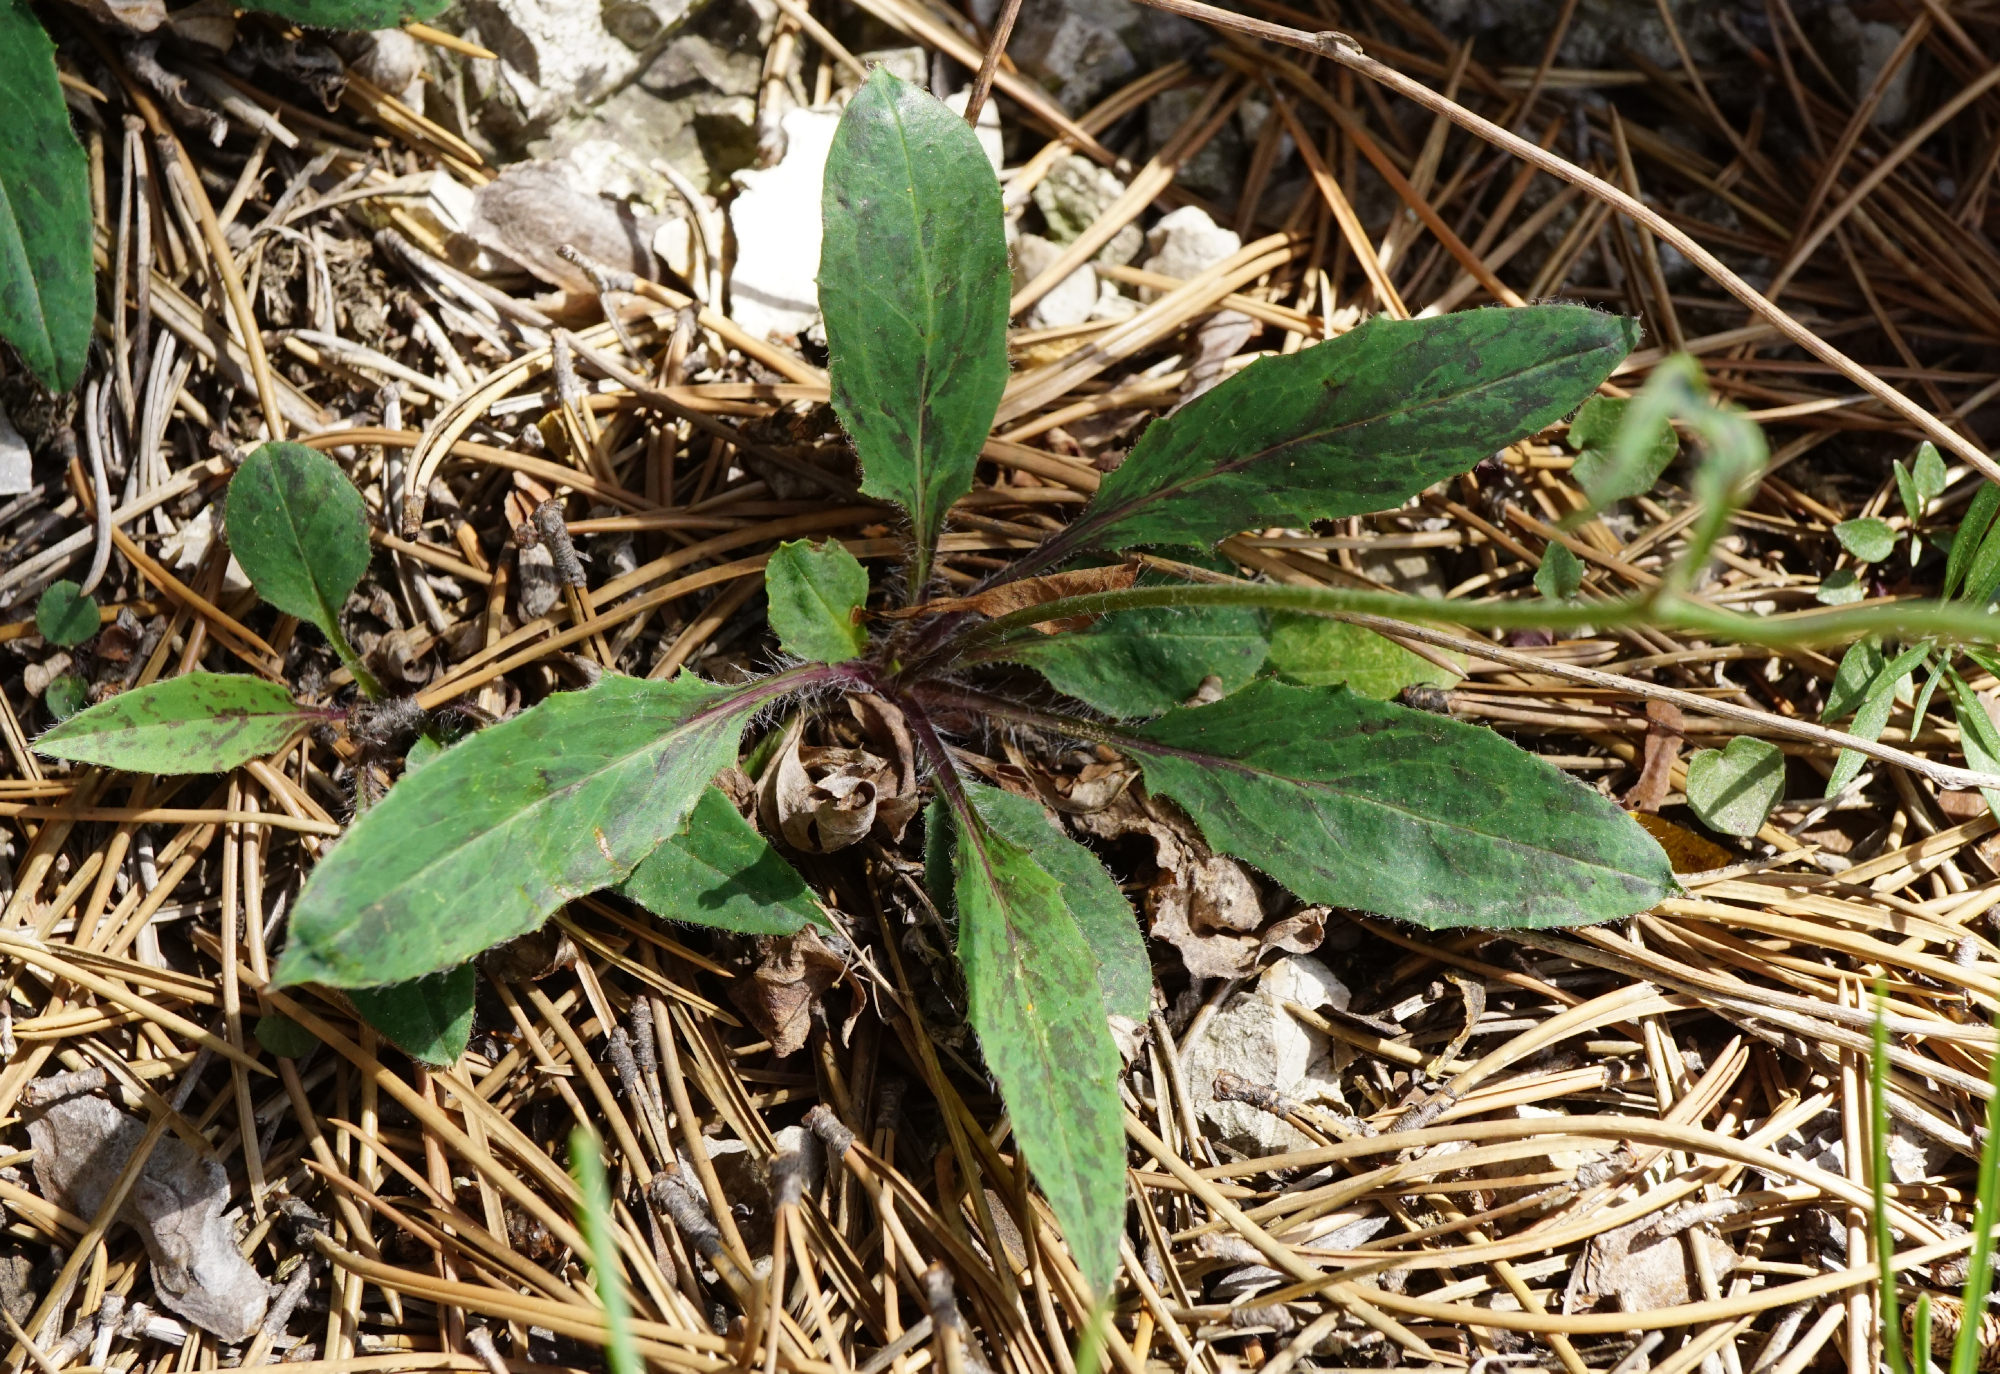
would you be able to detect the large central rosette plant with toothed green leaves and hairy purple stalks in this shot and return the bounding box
[42,70,1674,1294]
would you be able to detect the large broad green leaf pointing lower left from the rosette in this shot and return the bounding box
[278,674,772,988]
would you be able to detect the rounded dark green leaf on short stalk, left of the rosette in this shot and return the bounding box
[226,444,370,644]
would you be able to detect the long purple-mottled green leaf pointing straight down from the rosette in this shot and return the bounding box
[954,792,1124,1296]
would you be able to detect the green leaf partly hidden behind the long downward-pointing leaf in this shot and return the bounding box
[966,784,1152,1022]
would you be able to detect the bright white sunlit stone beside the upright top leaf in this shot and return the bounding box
[730,110,840,340]
